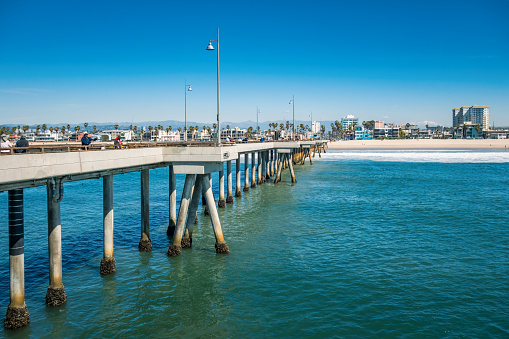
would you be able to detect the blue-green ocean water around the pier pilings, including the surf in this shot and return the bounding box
[0,150,509,338]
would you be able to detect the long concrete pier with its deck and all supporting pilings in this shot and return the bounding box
[0,141,327,329]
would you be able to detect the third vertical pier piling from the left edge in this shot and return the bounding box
[100,174,117,274]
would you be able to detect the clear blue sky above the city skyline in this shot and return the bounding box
[0,0,509,126]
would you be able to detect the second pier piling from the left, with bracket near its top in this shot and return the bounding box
[46,179,67,306]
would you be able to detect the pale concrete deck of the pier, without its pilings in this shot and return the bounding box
[0,141,326,191]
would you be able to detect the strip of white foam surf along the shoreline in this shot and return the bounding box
[322,150,509,163]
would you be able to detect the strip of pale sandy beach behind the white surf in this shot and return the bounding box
[329,139,509,149]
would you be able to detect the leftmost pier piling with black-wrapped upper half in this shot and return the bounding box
[4,188,30,329]
